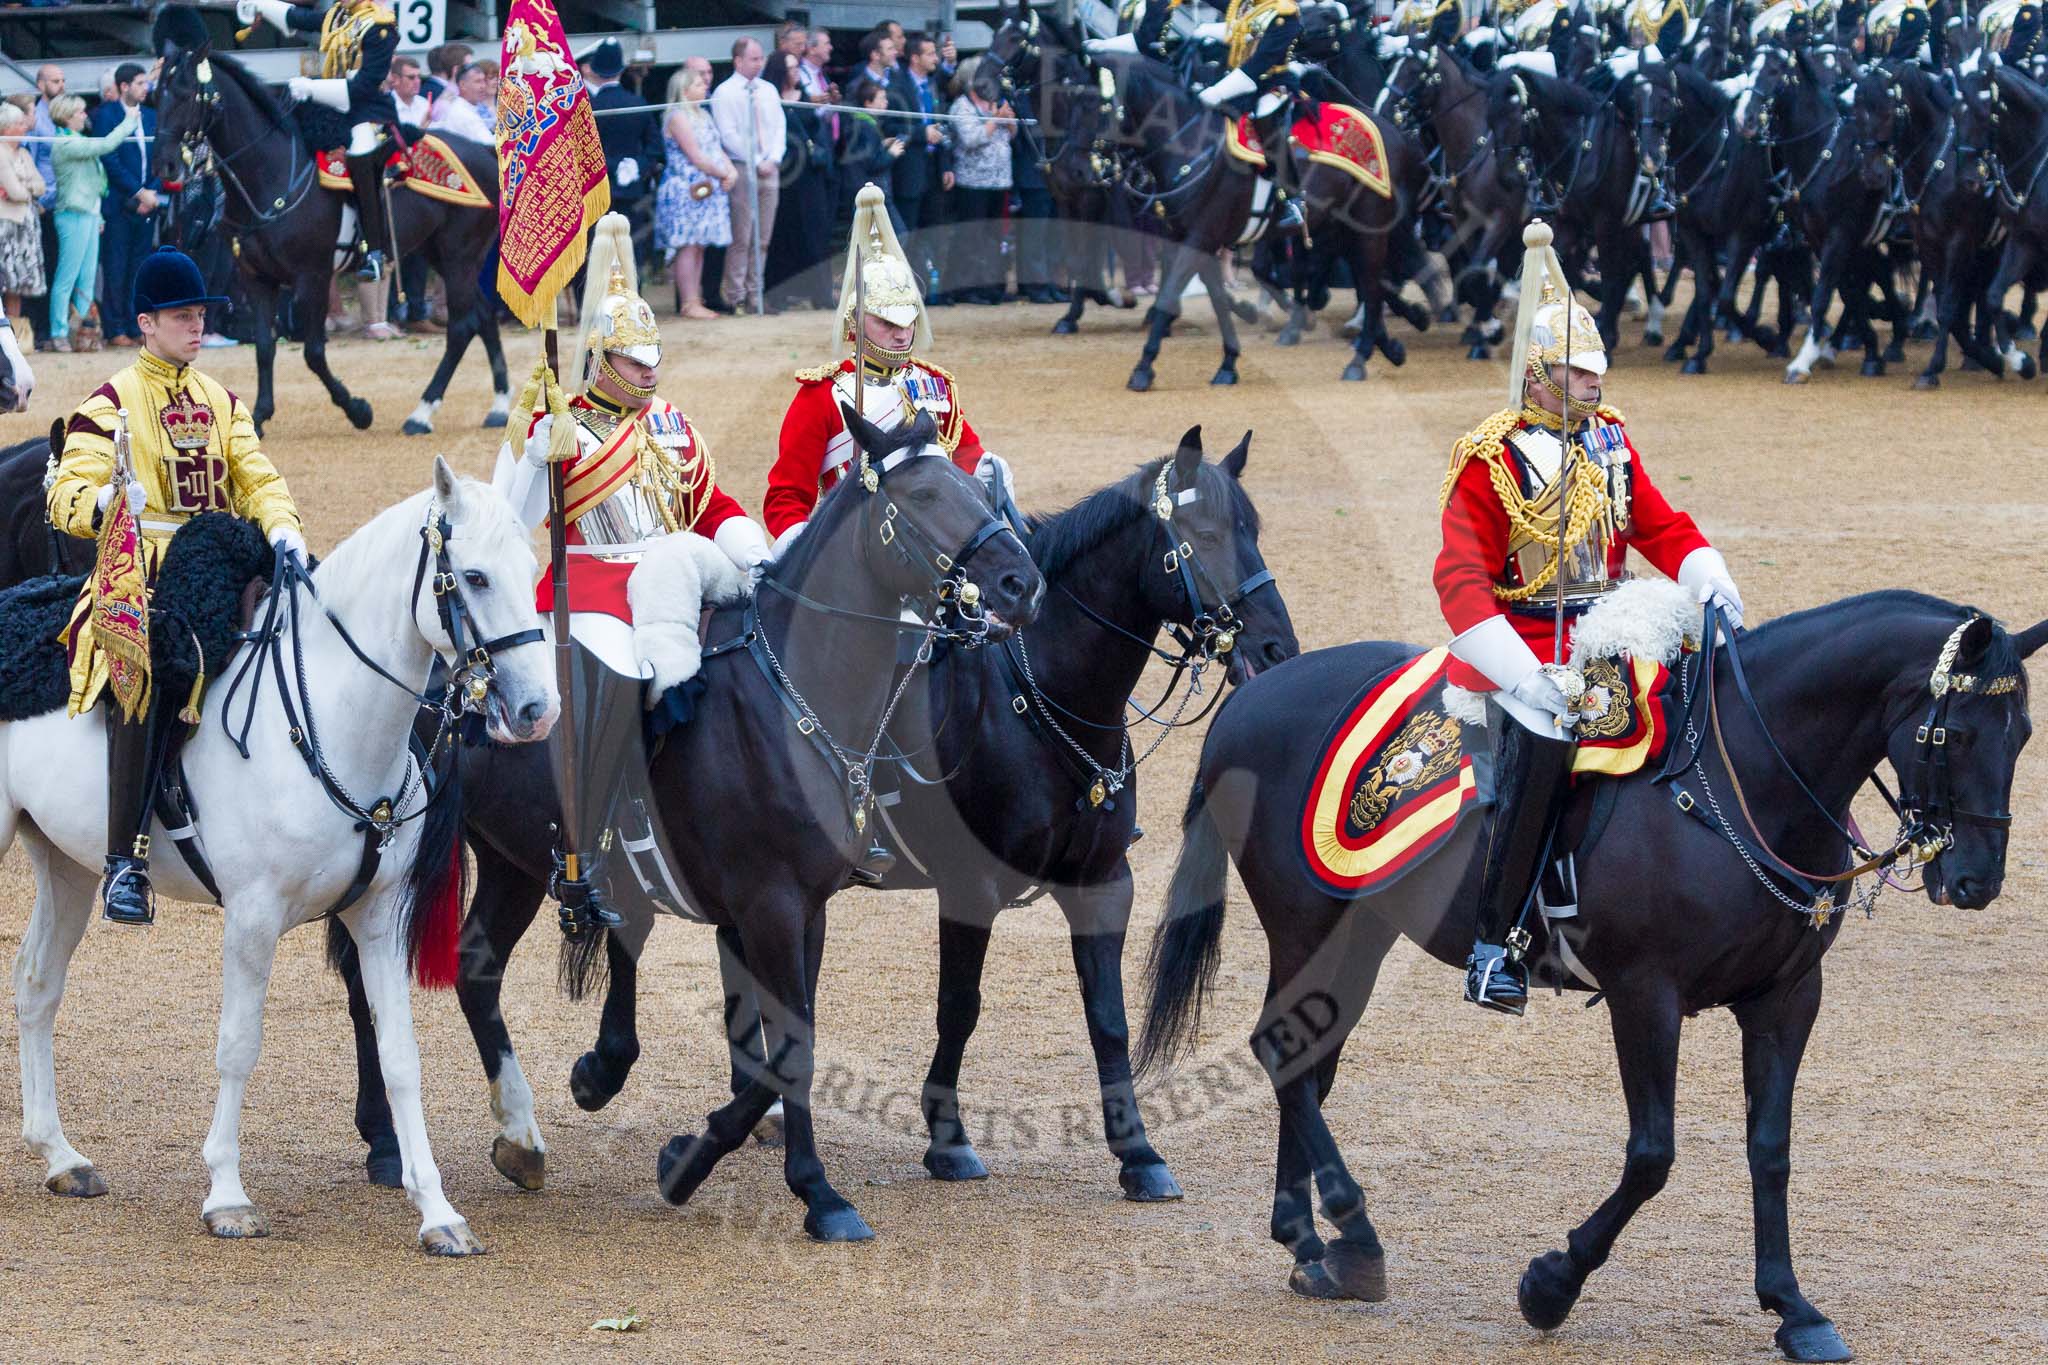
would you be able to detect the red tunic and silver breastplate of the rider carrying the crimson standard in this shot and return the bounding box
[526,393,745,622]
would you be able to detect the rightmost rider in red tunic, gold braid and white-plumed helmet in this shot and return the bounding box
[1436,221,1743,1015]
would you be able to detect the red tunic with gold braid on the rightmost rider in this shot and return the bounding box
[1436,407,1706,692]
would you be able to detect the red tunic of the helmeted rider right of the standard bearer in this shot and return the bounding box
[762,356,981,538]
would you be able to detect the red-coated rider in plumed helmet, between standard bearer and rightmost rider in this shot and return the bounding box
[762,184,1012,553]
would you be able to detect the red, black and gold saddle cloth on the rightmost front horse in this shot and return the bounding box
[1300,649,1671,896]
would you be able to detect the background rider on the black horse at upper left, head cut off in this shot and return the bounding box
[236,0,397,284]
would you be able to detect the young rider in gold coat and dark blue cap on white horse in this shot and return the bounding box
[49,246,305,925]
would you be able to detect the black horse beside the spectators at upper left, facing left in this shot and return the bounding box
[154,31,512,436]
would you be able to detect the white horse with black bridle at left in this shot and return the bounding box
[0,456,559,1257]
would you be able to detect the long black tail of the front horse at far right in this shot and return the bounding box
[1137,778,1231,1074]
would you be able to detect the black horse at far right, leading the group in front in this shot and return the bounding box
[1139,591,2048,1361]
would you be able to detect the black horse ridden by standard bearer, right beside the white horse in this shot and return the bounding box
[456,411,1044,1240]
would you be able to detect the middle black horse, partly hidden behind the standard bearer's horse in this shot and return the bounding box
[446,428,1296,1201]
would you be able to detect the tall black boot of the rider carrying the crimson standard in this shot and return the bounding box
[551,647,651,935]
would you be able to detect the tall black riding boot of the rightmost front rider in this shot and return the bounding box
[1464,706,1577,1015]
